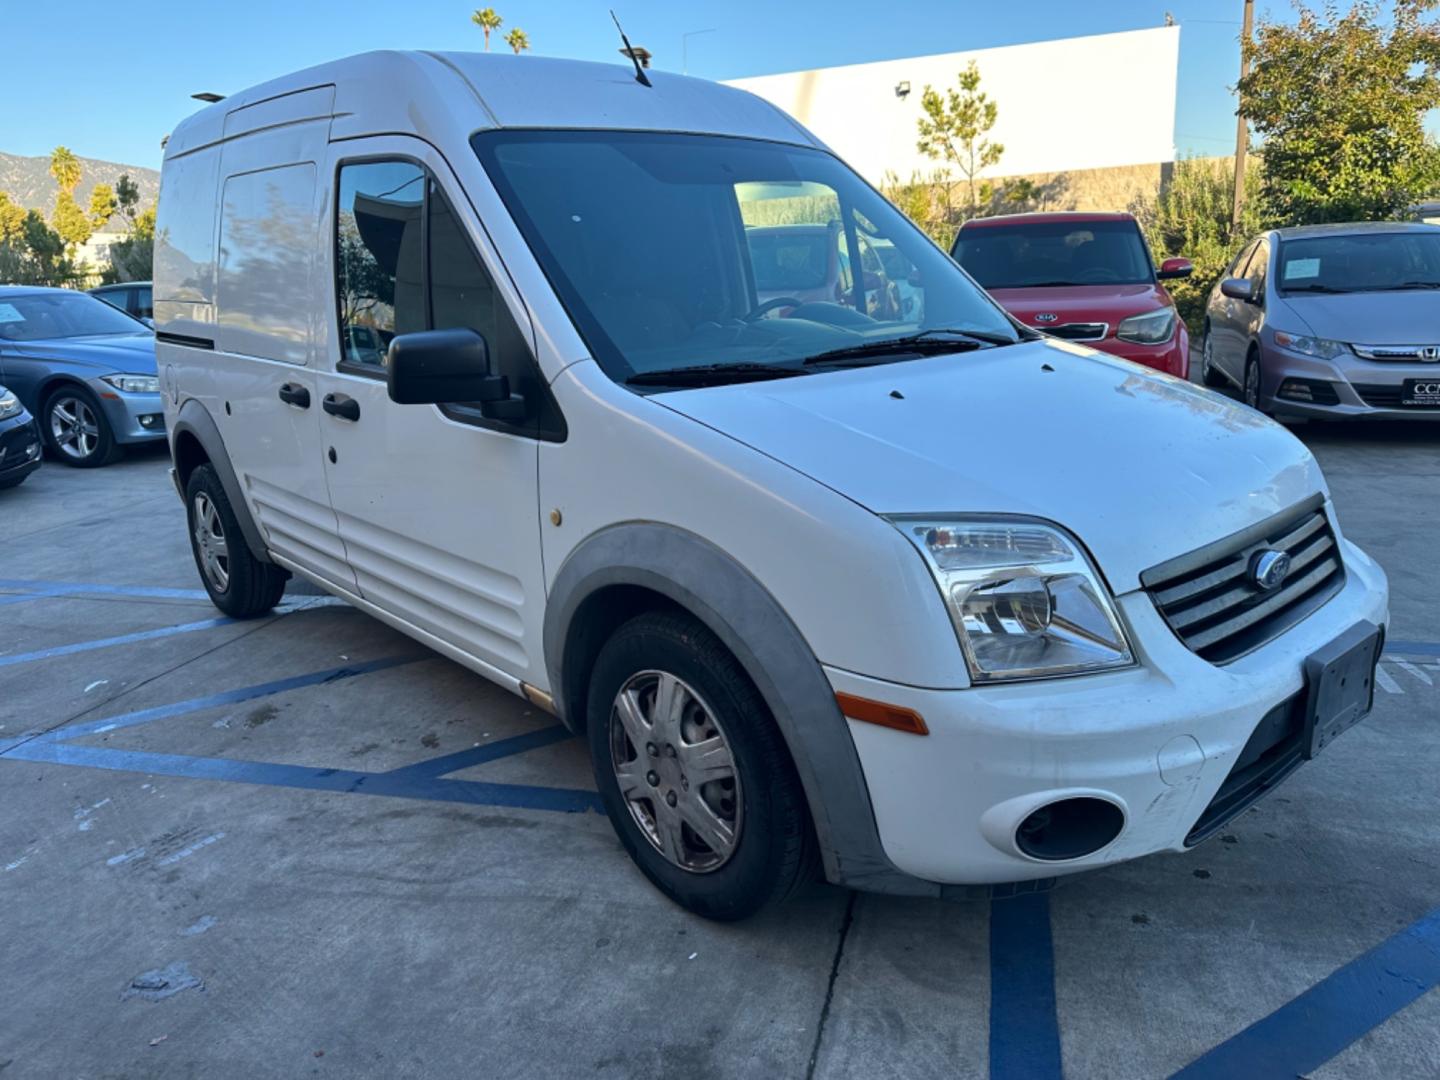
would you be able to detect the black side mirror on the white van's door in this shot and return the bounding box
[384,327,526,422]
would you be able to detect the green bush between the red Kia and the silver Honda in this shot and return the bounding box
[1130,157,1272,336]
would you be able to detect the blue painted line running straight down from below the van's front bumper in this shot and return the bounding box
[989,893,1061,1080]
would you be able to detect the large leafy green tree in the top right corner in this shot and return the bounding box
[1238,0,1440,225]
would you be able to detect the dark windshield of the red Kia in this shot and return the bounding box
[955,220,1155,289]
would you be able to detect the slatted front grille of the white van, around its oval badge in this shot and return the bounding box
[1140,495,1345,664]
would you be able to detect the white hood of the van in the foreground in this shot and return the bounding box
[652,341,1325,593]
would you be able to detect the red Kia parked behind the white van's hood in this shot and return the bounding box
[950,213,1192,379]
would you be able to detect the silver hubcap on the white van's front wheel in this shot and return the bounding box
[609,671,744,874]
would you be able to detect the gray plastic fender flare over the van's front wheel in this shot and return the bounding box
[544,523,939,896]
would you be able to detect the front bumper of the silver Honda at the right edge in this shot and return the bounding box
[1260,347,1440,422]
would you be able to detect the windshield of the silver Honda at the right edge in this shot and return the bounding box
[1276,229,1440,294]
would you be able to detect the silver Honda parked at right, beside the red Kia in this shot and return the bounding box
[1201,222,1440,420]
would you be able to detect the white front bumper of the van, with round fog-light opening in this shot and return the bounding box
[825,541,1388,886]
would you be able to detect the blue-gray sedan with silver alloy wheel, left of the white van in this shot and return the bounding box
[0,285,166,468]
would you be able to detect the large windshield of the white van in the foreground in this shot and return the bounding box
[472,131,1022,382]
